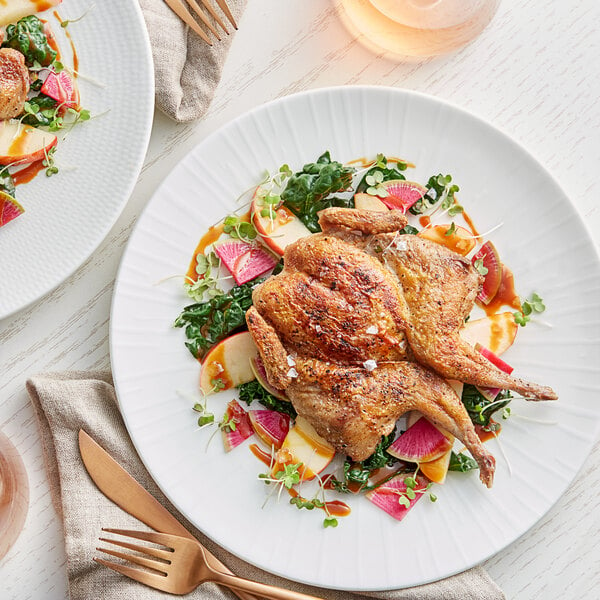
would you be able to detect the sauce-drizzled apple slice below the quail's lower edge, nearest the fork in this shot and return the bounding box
[272,417,335,481]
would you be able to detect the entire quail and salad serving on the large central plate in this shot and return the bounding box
[175,153,557,526]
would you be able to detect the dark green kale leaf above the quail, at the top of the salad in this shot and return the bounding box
[281,152,354,233]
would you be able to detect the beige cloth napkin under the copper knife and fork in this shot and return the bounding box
[27,372,505,600]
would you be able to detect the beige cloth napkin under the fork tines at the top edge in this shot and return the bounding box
[139,0,246,123]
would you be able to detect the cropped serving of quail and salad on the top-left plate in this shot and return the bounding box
[0,7,90,226]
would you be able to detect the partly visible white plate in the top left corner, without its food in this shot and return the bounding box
[0,0,154,319]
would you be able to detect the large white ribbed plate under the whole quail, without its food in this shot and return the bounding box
[111,87,600,590]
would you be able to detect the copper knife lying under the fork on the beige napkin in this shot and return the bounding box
[79,429,257,600]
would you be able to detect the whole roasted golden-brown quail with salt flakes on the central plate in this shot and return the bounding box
[246,208,557,487]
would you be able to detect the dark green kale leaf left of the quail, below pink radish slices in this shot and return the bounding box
[174,279,264,358]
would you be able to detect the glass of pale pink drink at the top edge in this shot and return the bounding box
[338,0,500,60]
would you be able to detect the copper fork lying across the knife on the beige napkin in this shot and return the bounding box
[94,528,320,600]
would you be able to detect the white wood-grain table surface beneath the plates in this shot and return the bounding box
[0,0,600,600]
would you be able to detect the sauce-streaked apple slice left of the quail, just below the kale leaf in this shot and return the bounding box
[200,331,258,396]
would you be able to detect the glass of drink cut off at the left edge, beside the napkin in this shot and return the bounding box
[0,431,29,559]
